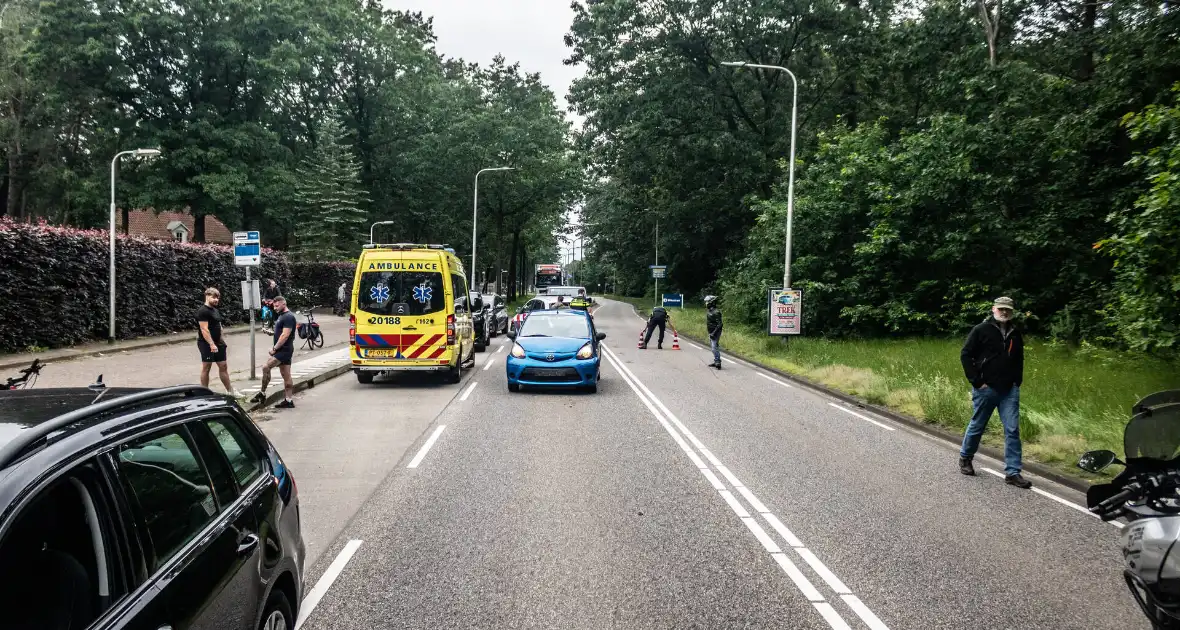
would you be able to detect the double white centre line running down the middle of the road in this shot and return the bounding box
[603,346,887,630]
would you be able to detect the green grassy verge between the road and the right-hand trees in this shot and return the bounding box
[617,298,1180,472]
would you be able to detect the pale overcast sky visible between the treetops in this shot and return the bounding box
[384,0,582,120]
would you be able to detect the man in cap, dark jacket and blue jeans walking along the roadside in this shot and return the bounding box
[959,297,1033,488]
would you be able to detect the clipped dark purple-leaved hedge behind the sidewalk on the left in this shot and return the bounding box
[0,219,290,352]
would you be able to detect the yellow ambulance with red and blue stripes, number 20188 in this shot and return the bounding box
[348,243,476,383]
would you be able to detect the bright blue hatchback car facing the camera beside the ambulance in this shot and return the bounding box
[507,310,607,393]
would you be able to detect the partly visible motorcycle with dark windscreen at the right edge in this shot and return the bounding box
[1077,389,1180,630]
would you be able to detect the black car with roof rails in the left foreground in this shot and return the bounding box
[0,386,306,630]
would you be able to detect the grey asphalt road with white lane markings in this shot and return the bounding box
[262,303,1147,630]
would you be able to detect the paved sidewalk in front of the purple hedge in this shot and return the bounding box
[8,313,348,393]
